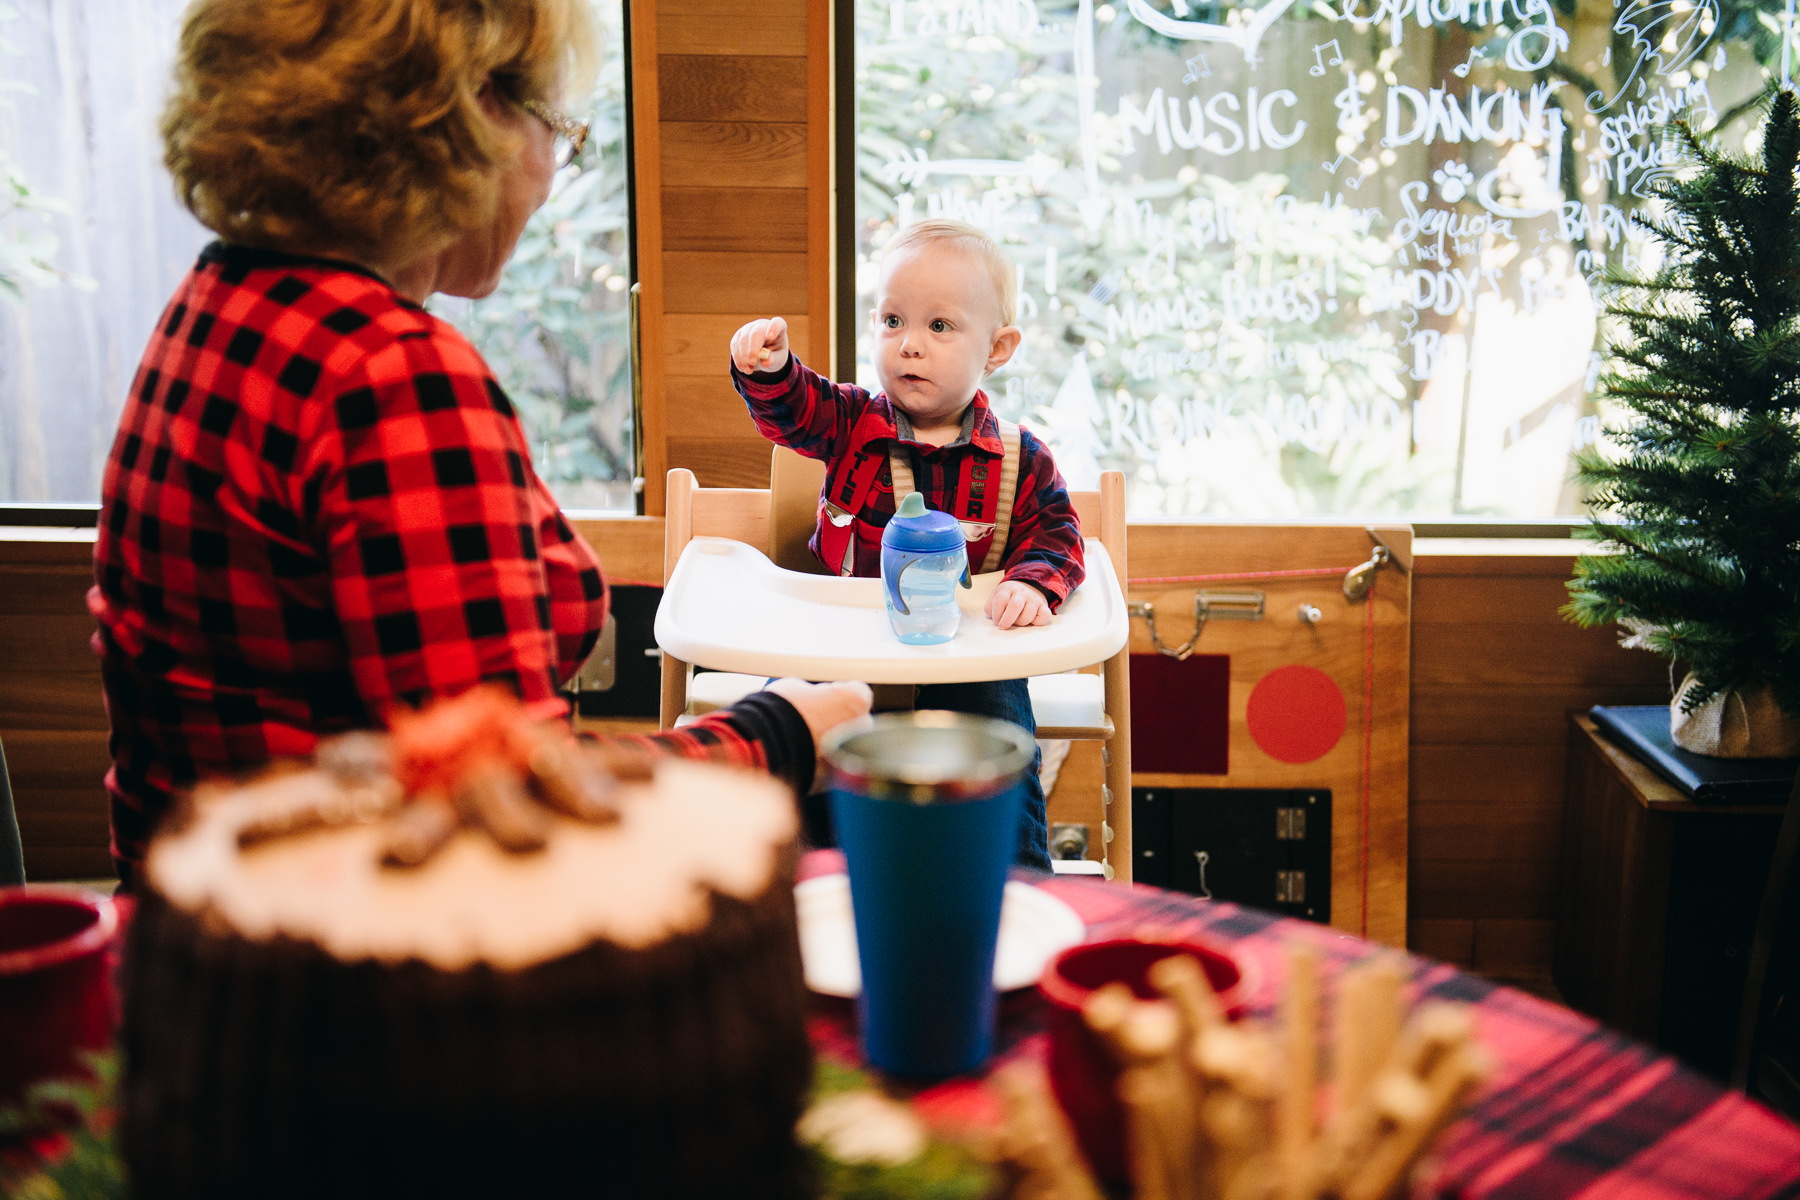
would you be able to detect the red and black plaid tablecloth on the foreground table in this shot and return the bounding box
[801,851,1800,1200]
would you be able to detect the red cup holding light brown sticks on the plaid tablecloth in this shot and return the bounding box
[1037,930,1253,1184]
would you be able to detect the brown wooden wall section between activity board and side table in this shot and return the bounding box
[1409,542,1669,979]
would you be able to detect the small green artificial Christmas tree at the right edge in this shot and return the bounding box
[1564,88,1800,756]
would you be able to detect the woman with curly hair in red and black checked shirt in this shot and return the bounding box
[88,0,868,883]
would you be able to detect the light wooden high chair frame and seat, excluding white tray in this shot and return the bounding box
[661,446,1132,882]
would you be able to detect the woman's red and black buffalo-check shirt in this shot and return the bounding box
[88,245,765,864]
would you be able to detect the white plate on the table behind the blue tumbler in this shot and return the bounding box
[794,874,1087,999]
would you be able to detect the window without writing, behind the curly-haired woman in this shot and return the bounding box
[0,0,634,510]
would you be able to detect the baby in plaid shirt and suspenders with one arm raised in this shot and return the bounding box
[731,219,1084,871]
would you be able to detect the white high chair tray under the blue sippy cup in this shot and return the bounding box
[655,538,1130,684]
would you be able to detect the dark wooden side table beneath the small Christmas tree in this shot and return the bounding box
[1553,714,1782,1079]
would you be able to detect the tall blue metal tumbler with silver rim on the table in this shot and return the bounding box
[823,712,1035,1079]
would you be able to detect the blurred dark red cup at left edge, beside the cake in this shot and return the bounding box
[0,885,119,1105]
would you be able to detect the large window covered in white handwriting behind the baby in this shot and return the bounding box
[842,0,1791,518]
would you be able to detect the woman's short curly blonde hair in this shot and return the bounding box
[162,0,598,263]
